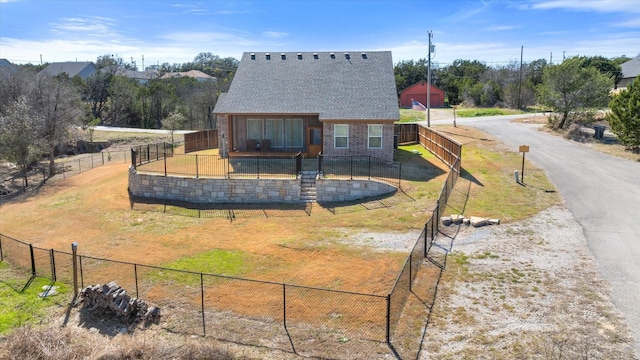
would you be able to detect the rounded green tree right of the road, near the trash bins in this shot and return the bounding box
[538,57,614,129]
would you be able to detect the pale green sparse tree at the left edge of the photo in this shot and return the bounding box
[0,96,44,186]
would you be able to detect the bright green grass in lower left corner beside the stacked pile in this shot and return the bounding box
[0,263,69,335]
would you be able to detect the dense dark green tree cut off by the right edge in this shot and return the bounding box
[609,76,640,152]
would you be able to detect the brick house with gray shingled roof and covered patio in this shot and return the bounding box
[213,51,400,161]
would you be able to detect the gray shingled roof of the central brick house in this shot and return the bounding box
[214,51,400,120]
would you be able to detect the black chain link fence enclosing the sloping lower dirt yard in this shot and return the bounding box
[0,123,460,359]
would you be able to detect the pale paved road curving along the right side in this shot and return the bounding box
[424,114,640,356]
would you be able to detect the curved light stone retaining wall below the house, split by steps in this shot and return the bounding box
[129,167,396,204]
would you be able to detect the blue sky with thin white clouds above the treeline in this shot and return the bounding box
[0,0,640,67]
